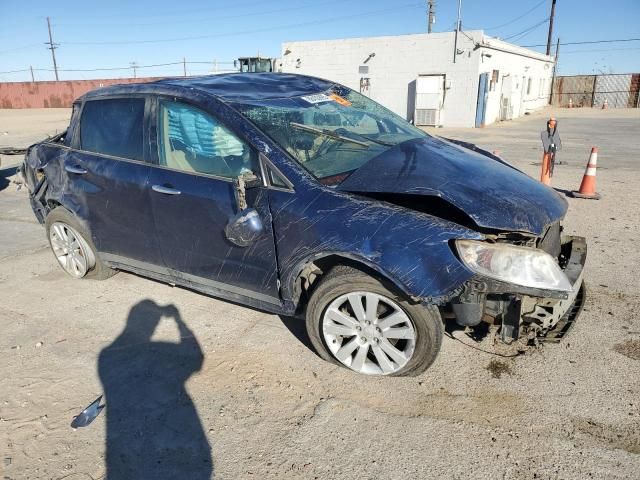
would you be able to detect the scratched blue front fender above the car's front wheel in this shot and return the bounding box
[271,182,483,310]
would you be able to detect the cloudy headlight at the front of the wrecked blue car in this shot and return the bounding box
[456,240,572,292]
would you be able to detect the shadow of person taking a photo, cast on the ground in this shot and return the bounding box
[98,300,213,480]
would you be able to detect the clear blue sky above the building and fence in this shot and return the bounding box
[0,0,640,81]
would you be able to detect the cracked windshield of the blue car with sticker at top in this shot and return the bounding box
[236,89,427,185]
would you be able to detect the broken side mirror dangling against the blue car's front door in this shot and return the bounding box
[224,172,264,247]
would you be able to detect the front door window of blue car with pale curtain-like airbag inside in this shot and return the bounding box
[158,100,259,178]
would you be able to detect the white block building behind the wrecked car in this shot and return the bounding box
[279,30,553,127]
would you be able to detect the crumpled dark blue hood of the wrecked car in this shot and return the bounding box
[337,137,567,235]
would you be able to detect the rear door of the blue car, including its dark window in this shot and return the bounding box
[64,96,163,270]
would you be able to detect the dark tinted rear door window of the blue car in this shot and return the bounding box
[80,98,144,160]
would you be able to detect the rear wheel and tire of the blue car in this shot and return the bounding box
[45,207,117,280]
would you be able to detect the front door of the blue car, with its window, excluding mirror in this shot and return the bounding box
[149,98,280,305]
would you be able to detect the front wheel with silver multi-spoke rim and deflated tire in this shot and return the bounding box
[306,266,444,376]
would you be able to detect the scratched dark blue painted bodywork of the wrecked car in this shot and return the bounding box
[25,74,566,314]
